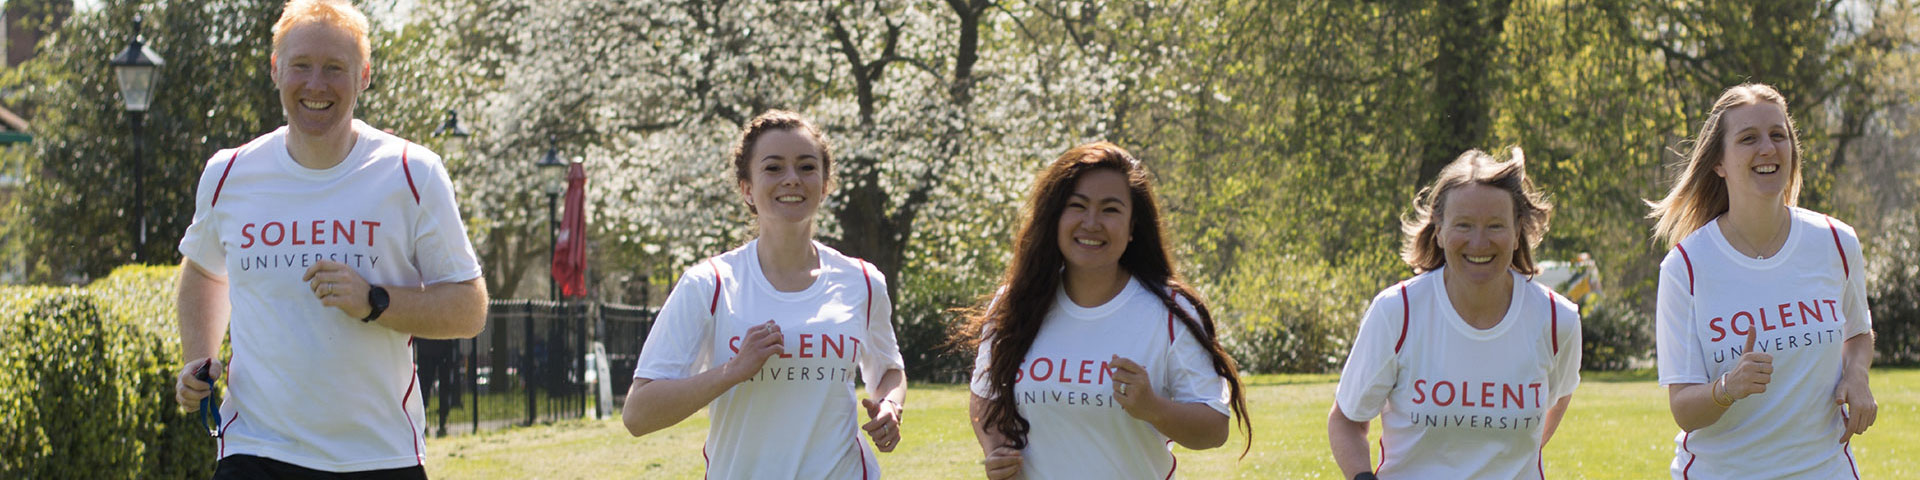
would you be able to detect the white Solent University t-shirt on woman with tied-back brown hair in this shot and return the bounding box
[634,240,906,478]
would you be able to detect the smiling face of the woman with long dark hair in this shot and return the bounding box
[1058,169,1133,276]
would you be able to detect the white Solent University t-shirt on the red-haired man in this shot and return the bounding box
[180,121,480,472]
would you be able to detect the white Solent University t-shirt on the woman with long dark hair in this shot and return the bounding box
[972,278,1233,478]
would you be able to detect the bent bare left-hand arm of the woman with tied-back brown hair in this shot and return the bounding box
[620,321,787,436]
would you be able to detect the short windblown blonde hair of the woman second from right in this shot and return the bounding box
[1400,146,1553,275]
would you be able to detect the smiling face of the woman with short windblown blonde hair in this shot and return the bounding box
[1436,184,1519,284]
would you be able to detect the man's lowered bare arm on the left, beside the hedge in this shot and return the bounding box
[173,259,232,411]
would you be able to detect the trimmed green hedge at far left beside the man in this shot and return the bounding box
[0,265,215,478]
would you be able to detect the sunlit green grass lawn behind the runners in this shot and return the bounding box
[426,369,1920,478]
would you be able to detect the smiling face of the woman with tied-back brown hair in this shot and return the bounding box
[739,129,828,223]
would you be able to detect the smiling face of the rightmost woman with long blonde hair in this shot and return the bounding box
[1713,102,1797,204]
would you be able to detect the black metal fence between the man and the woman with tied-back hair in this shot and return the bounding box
[413,300,657,434]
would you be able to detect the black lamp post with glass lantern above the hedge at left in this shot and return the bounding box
[108,13,167,261]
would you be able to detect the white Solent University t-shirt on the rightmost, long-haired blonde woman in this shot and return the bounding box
[1655,207,1874,478]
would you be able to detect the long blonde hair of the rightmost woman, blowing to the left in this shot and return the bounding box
[1647,83,1801,248]
